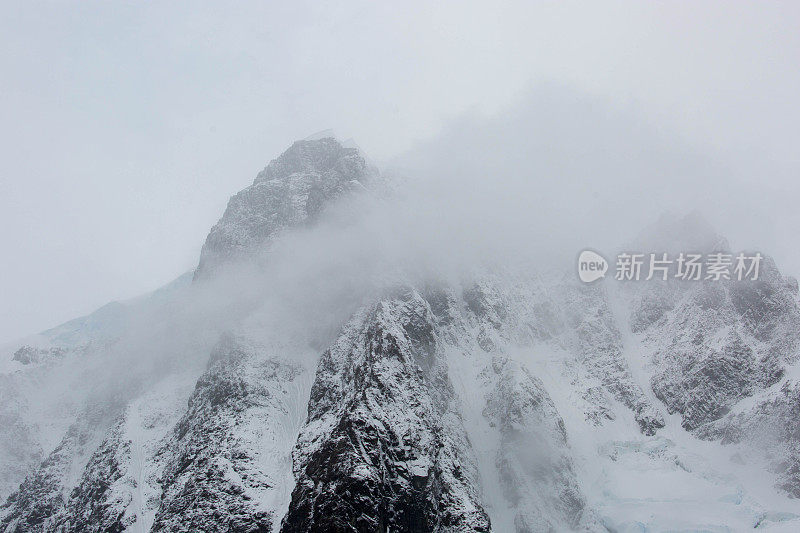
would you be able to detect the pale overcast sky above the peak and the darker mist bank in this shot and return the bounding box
[0,1,800,341]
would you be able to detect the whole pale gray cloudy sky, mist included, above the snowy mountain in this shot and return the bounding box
[0,2,800,339]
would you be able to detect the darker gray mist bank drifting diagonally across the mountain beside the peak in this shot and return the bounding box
[25,81,793,414]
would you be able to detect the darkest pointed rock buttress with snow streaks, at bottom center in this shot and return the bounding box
[282,290,489,532]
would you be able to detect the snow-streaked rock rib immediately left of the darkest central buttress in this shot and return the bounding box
[152,337,304,533]
